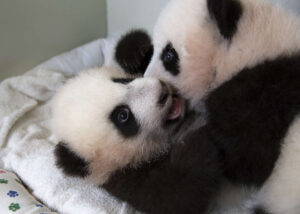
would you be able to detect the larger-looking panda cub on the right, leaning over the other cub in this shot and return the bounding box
[141,0,300,214]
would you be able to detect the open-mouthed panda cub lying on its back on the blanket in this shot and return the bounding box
[52,32,221,214]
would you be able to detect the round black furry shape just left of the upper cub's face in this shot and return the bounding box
[115,30,153,75]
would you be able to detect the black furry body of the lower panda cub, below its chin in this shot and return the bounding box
[103,131,221,214]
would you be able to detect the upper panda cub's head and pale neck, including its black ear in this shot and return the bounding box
[145,0,300,108]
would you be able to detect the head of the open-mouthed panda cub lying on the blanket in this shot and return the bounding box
[52,67,185,184]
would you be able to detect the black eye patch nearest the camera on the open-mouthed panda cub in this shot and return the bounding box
[110,105,140,137]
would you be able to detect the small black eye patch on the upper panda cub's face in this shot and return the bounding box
[160,43,179,76]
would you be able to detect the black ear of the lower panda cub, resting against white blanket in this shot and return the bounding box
[54,142,90,178]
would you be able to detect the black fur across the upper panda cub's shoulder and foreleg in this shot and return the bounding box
[205,55,300,186]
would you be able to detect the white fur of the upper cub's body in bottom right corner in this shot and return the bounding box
[246,116,300,214]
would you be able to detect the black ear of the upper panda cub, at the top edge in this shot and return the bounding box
[207,0,243,40]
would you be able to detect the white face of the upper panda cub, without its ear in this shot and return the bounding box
[145,0,219,108]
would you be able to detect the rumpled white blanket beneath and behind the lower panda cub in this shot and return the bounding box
[0,40,135,214]
